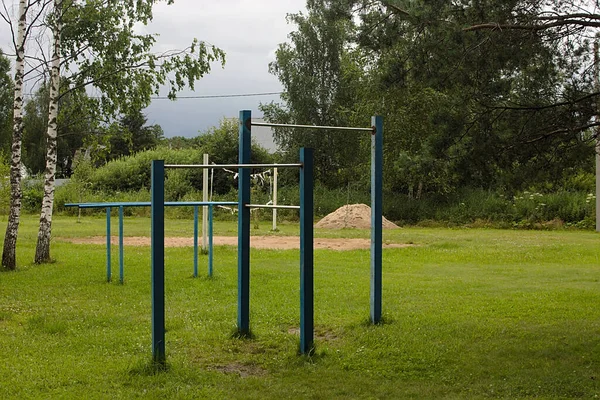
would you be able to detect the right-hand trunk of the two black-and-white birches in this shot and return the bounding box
[34,0,62,264]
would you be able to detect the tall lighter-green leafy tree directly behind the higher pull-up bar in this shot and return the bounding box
[261,2,370,187]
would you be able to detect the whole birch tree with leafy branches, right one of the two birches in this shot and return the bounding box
[35,0,225,263]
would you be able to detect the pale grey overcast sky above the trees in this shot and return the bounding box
[0,0,305,137]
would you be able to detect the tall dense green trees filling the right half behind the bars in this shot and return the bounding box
[262,0,600,197]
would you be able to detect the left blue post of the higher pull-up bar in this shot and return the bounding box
[238,110,252,334]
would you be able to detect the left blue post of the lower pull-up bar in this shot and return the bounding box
[150,160,166,364]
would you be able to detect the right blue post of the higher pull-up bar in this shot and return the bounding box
[371,116,383,324]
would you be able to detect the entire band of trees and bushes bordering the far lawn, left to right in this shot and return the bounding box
[0,0,600,228]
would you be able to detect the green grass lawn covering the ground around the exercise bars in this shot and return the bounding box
[0,216,600,399]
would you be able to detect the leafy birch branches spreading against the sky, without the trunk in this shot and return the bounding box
[61,0,225,117]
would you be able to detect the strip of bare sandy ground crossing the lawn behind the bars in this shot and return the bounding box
[64,236,413,250]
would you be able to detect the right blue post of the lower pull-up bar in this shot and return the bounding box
[300,148,314,354]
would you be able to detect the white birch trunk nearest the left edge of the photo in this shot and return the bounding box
[2,0,27,270]
